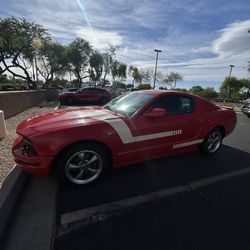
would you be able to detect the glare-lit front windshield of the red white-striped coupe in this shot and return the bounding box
[104,92,154,117]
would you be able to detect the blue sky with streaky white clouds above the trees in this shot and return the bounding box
[0,0,250,89]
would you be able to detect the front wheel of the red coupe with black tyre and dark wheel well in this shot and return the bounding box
[56,143,109,185]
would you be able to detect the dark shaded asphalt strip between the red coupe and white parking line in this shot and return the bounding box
[57,145,250,215]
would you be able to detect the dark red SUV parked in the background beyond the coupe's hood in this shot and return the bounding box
[59,88,111,105]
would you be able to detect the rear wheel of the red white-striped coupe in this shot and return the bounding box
[201,128,224,155]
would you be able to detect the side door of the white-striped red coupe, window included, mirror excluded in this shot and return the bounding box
[136,95,200,157]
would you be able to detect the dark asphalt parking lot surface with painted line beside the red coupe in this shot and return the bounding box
[54,113,250,250]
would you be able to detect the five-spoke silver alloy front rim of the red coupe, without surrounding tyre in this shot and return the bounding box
[65,150,103,184]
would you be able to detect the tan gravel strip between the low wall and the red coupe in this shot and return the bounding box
[0,103,56,186]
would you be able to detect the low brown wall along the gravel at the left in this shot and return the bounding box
[0,90,58,119]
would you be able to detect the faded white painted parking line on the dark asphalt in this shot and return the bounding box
[61,168,250,225]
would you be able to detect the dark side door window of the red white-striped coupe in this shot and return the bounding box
[152,95,195,115]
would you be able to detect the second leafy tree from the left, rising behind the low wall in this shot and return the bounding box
[37,40,68,89]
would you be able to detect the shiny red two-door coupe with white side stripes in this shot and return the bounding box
[13,90,236,185]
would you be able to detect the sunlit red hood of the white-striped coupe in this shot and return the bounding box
[16,107,118,136]
